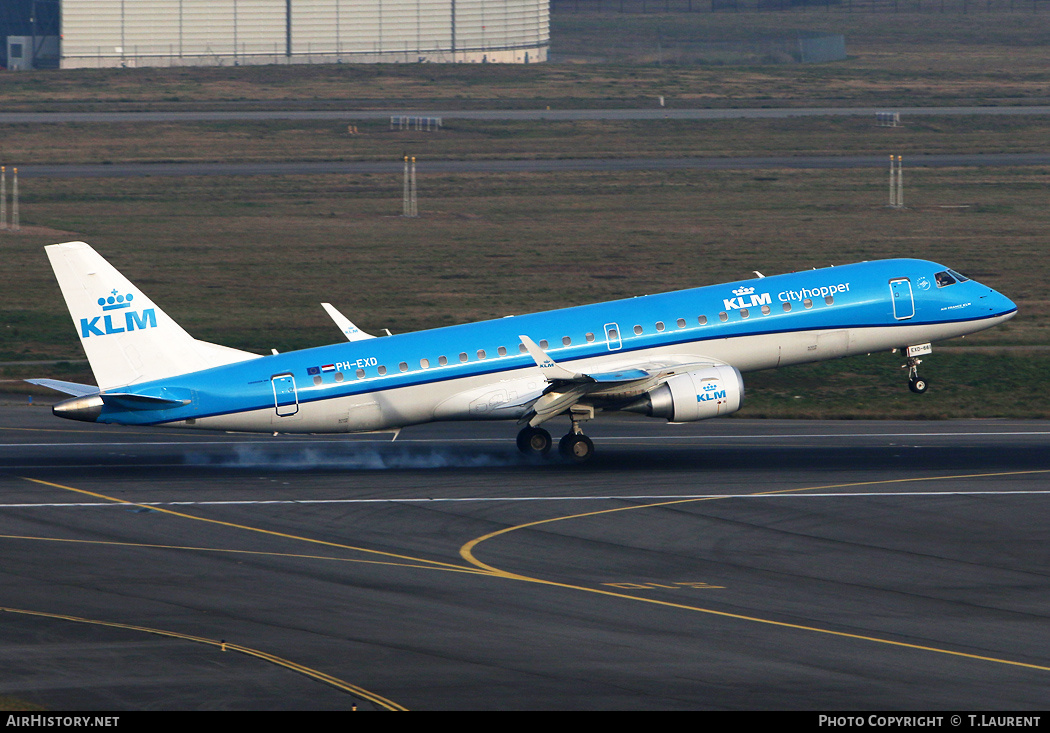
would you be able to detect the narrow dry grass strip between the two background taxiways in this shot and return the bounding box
[0,114,1050,166]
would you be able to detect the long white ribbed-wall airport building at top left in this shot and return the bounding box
[0,0,550,68]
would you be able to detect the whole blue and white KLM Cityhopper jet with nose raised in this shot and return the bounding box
[30,242,1017,461]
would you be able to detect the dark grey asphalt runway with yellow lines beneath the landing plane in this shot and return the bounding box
[0,404,1050,711]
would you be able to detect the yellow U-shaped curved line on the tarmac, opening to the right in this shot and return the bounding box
[460,470,1050,672]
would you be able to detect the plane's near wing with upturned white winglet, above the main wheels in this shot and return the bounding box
[519,336,722,427]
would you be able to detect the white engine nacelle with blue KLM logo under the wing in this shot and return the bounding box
[628,365,743,422]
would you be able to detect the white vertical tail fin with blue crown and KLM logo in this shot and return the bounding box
[44,242,256,390]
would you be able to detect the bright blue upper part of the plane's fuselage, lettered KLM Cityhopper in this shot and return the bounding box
[94,259,1015,424]
